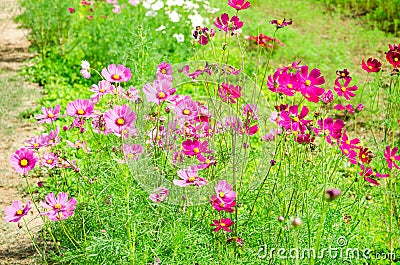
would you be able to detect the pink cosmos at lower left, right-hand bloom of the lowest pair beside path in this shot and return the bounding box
[40,192,77,221]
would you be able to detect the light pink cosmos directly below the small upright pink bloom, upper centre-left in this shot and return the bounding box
[143,79,176,105]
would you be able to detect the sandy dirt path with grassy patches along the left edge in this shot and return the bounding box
[0,0,40,265]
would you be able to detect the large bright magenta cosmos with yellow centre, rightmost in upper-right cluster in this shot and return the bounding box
[297,66,325,103]
